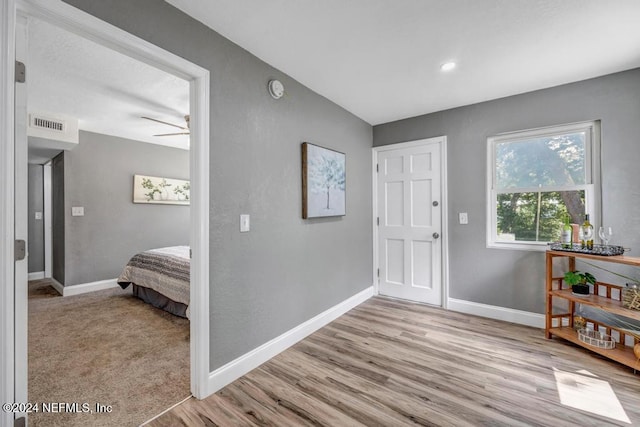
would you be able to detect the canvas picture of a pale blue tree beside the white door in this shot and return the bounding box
[302,142,347,219]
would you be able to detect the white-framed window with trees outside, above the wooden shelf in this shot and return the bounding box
[487,121,600,250]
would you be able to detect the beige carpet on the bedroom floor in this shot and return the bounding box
[29,281,190,427]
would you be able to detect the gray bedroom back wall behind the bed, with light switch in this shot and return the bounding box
[63,131,189,286]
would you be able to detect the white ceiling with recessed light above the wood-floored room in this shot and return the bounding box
[166,0,640,124]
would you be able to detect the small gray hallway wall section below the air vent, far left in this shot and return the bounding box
[28,165,44,273]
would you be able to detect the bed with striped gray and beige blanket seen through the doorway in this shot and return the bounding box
[118,246,191,318]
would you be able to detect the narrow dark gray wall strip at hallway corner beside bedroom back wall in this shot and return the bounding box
[51,152,66,284]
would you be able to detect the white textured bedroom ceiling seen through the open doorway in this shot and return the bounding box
[27,19,189,154]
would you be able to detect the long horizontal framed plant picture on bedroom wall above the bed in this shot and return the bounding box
[133,175,191,205]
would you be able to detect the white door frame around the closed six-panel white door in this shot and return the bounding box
[371,136,449,309]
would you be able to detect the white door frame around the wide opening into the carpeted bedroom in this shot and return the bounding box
[0,0,210,425]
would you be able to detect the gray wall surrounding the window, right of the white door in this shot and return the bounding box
[373,69,640,313]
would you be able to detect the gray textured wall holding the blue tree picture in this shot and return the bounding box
[62,0,373,370]
